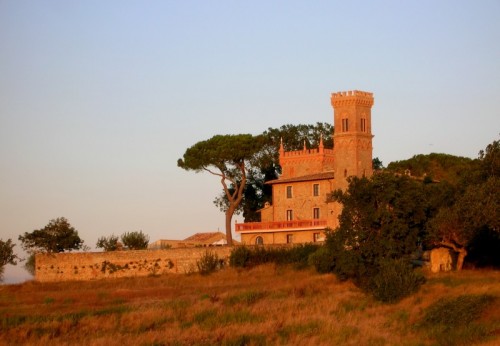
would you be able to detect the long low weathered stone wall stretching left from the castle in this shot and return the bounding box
[35,246,231,282]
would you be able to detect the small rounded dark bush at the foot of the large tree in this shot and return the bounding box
[367,259,425,303]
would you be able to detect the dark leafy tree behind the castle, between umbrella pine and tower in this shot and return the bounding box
[214,122,333,222]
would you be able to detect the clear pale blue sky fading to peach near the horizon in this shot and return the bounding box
[0,0,500,281]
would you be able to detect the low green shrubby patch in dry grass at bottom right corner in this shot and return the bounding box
[419,294,498,345]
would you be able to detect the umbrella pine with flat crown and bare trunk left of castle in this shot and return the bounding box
[177,134,262,245]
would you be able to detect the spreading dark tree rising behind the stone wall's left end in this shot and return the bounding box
[19,217,83,254]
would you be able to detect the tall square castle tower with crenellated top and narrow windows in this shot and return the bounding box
[331,90,373,189]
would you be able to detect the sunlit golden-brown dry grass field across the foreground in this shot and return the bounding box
[0,265,500,346]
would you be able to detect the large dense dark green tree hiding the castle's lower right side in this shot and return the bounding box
[326,173,428,288]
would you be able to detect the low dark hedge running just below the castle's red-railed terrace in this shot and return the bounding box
[229,244,319,269]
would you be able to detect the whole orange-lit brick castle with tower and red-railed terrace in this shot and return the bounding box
[236,90,373,245]
